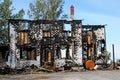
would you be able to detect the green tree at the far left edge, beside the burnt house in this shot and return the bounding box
[0,0,24,45]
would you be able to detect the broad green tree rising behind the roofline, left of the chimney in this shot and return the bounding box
[28,0,64,20]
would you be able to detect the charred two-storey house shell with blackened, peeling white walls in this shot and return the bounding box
[0,19,107,68]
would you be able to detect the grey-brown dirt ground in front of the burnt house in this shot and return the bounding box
[0,70,120,80]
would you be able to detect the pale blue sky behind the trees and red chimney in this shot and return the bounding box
[12,0,120,59]
